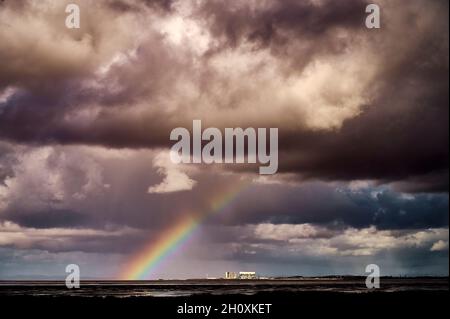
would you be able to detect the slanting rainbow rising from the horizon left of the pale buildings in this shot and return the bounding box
[120,182,248,280]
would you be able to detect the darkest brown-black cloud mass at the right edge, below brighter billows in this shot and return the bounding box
[280,86,449,192]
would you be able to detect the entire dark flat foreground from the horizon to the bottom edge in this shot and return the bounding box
[0,279,448,319]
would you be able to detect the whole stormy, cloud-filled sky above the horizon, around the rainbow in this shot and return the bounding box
[0,0,449,280]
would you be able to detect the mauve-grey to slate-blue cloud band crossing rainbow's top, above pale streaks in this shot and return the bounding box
[0,146,448,235]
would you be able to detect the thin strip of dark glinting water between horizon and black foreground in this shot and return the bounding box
[0,278,449,298]
